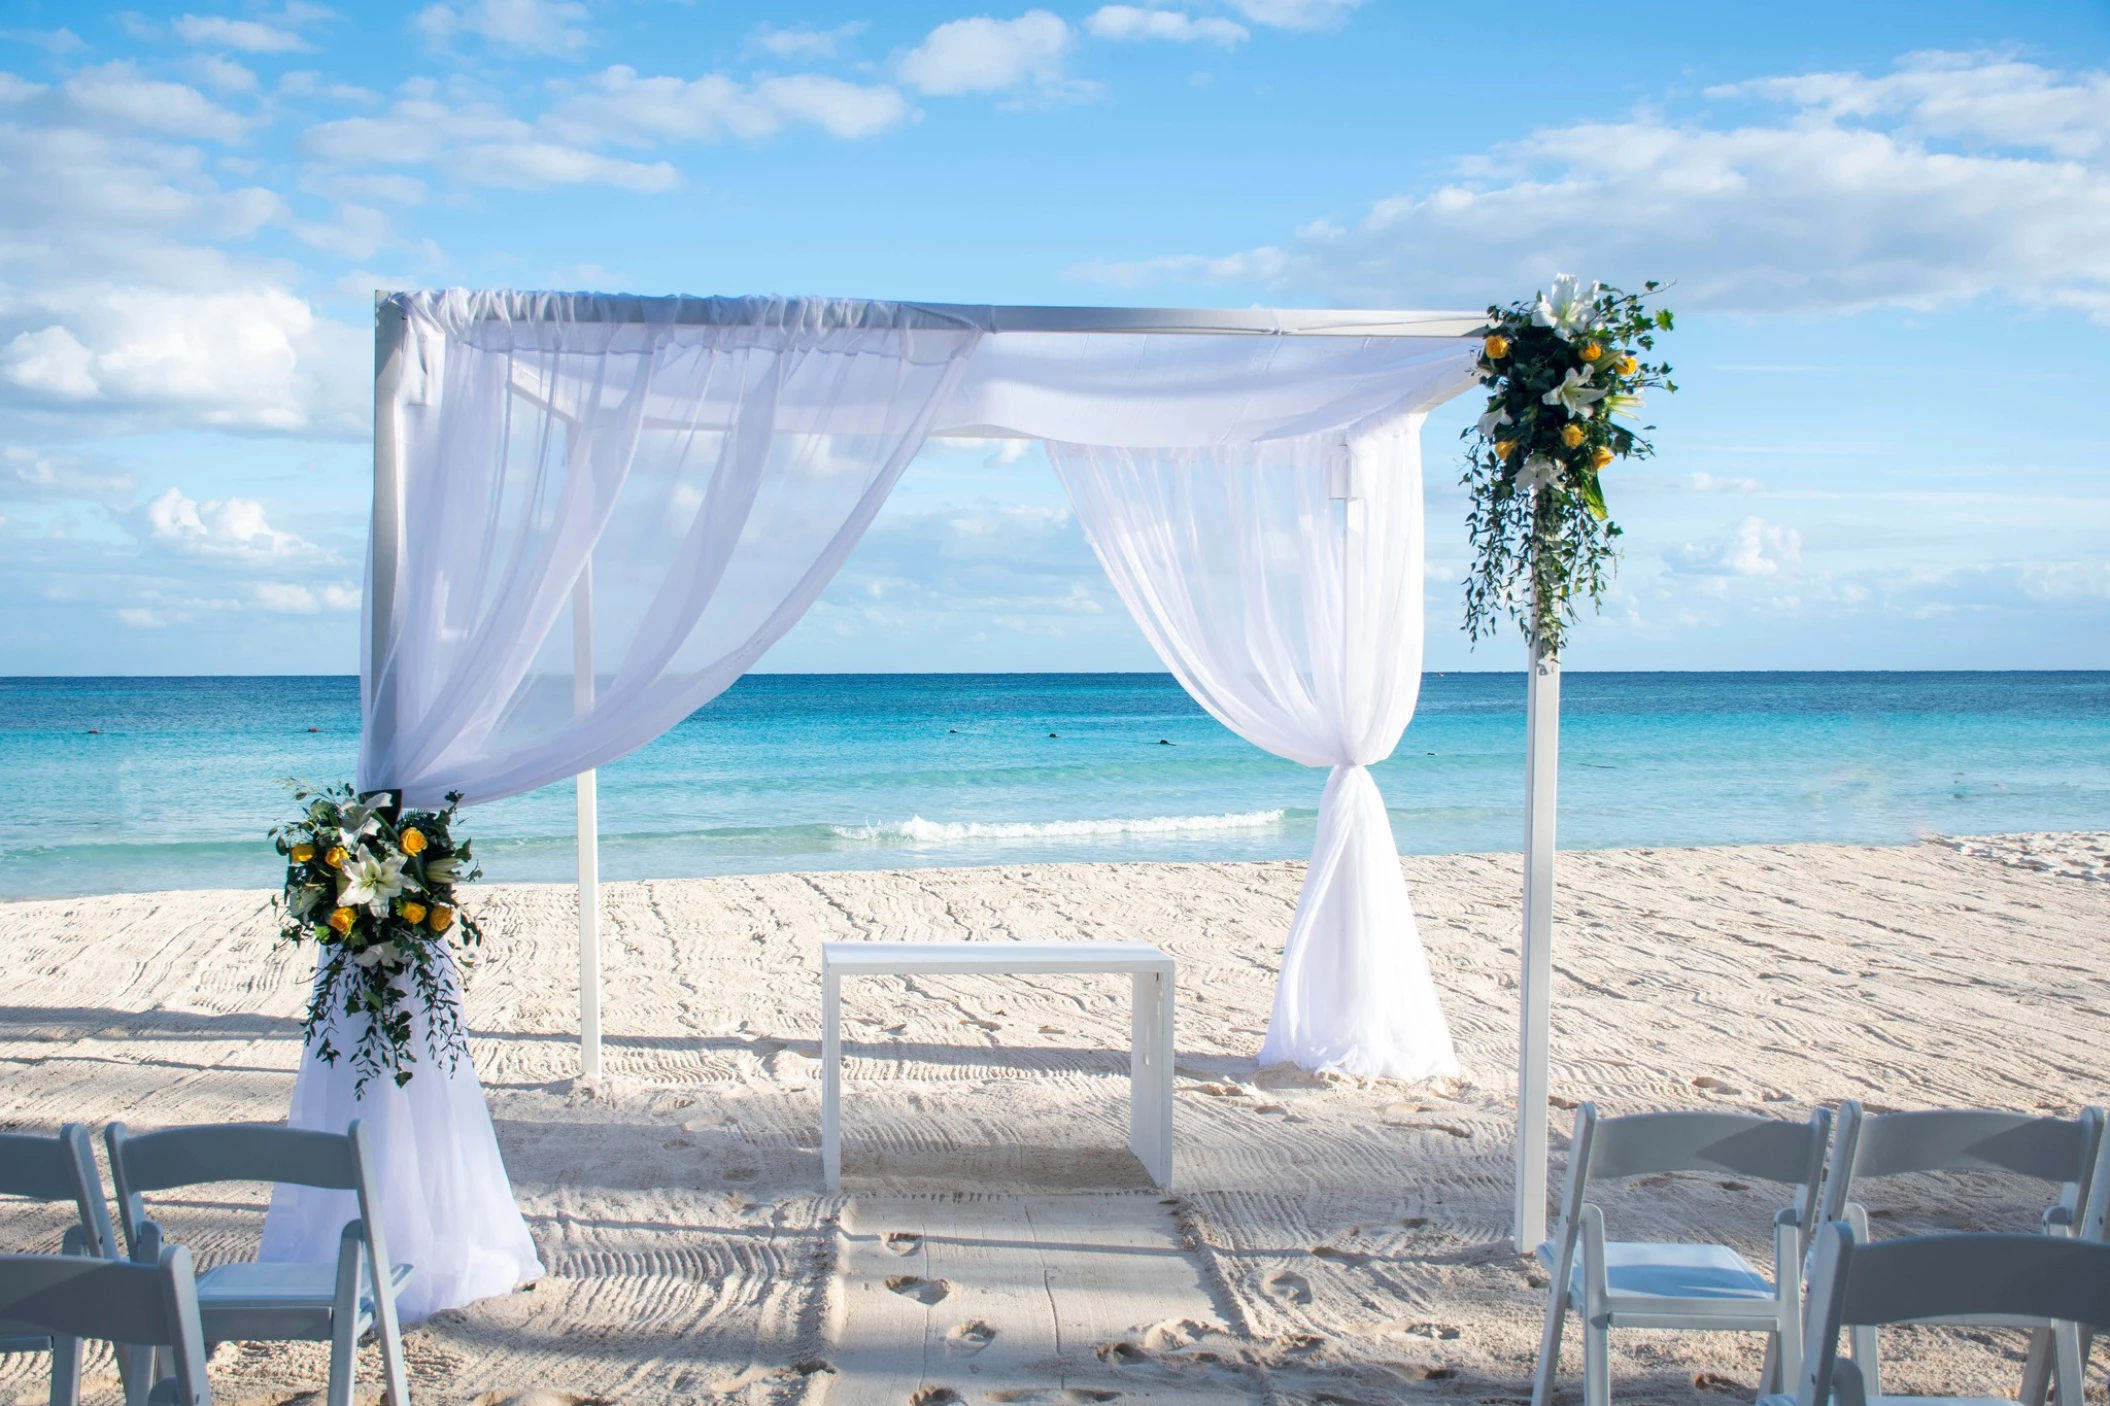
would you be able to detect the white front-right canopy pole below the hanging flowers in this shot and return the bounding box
[1513,620,1561,1254]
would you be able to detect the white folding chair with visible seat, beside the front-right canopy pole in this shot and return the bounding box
[1532,1104,1831,1406]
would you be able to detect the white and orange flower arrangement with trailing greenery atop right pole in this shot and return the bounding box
[1462,274,1677,657]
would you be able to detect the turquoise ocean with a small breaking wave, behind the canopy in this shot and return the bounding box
[0,673,2110,897]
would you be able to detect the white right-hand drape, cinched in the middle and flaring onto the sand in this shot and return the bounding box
[1049,414,1458,1079]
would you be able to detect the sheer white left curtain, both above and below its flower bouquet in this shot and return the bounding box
[264,291,979,1322]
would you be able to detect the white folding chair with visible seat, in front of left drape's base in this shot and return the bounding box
[103,1119,411,1406]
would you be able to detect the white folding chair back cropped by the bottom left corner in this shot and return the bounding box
[0,1246,213,1406]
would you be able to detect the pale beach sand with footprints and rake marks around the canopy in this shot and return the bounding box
[0,836,2110,1406]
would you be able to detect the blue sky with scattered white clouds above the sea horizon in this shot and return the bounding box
[0,0,2110,673]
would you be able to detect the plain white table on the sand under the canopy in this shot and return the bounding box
[821,942,1173,1191]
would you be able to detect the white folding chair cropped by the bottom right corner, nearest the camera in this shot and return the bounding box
[1758,1220,2110,1406]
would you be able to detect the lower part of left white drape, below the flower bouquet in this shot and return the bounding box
[260,954,542,1324]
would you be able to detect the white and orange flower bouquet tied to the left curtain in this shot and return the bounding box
[272,781,483,1098]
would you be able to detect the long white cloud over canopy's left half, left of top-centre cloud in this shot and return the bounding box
[542,63,909,146]
